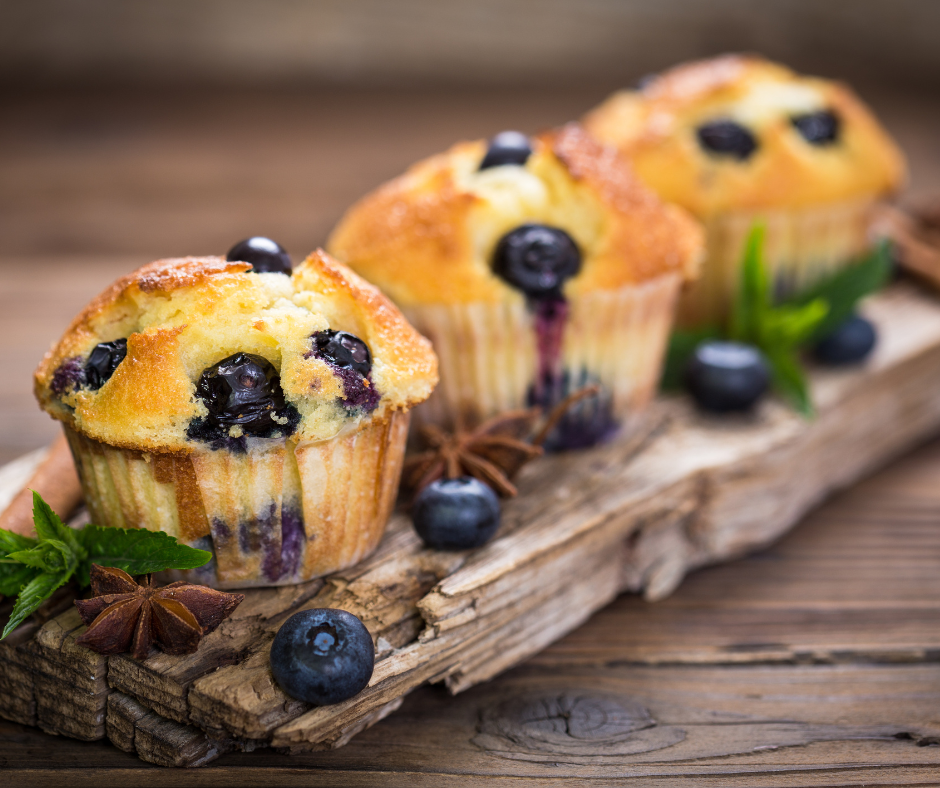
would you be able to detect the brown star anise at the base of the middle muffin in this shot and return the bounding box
[403,386,599,497]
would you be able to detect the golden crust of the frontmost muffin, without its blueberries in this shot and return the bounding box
[35,250,437,452]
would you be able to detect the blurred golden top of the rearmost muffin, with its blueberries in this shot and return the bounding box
[584,55,905,218]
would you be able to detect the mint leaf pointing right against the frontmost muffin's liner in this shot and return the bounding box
[80,525,212,575]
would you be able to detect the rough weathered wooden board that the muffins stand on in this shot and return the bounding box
[0,283,940,766]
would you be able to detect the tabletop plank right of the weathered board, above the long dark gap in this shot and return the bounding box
[530,443,940,668]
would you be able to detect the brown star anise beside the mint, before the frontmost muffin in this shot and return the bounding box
[75,564,245,659]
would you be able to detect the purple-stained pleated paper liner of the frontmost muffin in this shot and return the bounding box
[65,412,409,588]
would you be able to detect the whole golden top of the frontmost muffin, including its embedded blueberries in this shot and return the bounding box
[35,251,437,452]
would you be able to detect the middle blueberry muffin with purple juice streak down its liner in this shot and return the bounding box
[328,125,701,448]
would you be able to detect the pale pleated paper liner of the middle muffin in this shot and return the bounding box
[405,274,681,448]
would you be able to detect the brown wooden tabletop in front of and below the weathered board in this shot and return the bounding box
[0,443,940,788]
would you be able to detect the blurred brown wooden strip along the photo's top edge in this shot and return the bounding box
[0,0,940,87]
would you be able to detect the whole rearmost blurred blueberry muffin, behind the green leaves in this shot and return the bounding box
[584,55,905,325]
